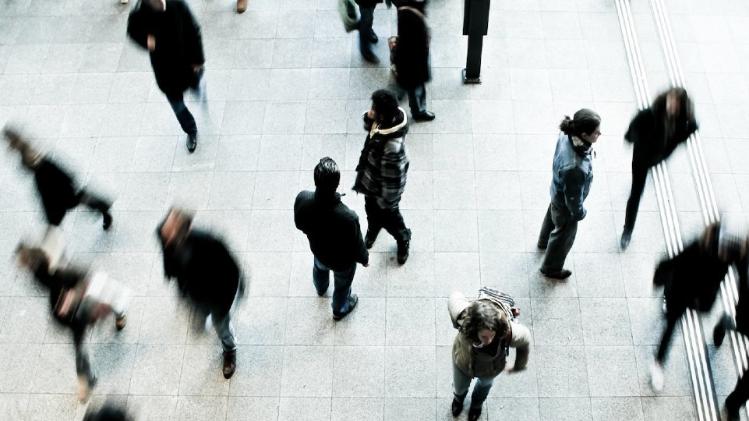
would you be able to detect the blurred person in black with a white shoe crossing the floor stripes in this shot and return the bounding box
[650,223,742,391]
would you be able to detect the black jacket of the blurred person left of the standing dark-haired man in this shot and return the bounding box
[157,226,243,317]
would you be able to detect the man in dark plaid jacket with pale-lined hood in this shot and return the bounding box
[353,89,411,264]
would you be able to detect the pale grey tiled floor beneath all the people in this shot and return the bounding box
[0,0,749,421]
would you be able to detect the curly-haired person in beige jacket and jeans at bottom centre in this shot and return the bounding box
[447,287,531,421]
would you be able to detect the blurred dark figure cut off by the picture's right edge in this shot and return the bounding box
[713,231,749,421]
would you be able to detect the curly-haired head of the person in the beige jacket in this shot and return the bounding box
[461,300,510,347]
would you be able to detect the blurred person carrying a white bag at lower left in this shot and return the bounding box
[16,243,126,401]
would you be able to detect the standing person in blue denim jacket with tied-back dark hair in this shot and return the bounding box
[538,108,601,279]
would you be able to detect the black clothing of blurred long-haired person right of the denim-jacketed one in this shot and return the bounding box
[624,108,697,232]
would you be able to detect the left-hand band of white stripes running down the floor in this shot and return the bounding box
[616,0,714,420]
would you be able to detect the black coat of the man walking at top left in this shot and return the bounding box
[127,0,205,96]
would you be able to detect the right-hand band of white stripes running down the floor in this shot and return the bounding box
[650,0,749,414]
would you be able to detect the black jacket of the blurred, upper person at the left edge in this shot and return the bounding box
[33,158,80,226]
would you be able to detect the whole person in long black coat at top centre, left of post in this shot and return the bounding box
[391,3,434,121]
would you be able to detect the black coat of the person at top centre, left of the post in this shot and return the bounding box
[393,7,432,89]
